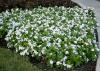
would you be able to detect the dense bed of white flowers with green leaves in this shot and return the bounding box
[0,6,99,68]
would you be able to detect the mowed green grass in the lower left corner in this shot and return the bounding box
[0,48,42,71]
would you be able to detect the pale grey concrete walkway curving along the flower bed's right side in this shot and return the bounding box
[72,0,100,71]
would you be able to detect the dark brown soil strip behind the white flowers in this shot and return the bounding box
[0,0,80,12]
